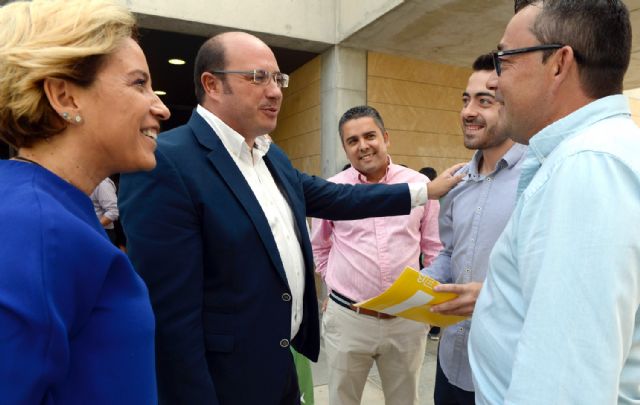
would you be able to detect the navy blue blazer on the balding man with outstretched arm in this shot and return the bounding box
[119,111,411,405]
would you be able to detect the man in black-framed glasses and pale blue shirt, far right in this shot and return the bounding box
[469,0,640,405]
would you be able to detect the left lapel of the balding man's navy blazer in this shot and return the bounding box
[189,111,288,285]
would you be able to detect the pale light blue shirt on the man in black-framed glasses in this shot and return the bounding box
[469,95,640,405]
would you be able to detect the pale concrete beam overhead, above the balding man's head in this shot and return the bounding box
[128,0,405,52]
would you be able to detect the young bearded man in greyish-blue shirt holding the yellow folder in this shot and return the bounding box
[423,54,526,405]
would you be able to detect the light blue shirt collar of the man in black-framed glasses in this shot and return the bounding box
[529,94,631,163]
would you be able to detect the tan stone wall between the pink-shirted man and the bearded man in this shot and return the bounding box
[367,52,473,173]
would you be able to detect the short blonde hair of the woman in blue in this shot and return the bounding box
[0,0,135,147]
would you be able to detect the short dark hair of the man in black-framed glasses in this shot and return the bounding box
[515,0,631,98]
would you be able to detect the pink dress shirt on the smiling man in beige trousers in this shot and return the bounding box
[311,163,442,301]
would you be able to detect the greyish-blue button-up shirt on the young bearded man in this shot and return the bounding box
[423,144,527,391]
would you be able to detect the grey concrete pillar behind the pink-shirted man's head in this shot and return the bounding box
[320,45,367,178]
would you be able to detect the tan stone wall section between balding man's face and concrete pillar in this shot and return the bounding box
[271,56,321,175]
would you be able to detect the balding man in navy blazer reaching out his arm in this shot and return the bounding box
[120,32,459,405]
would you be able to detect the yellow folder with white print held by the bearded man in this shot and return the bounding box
[355,267,467,327]
